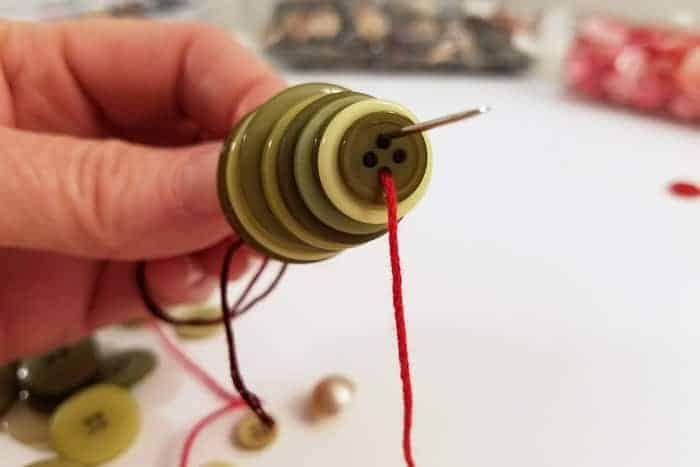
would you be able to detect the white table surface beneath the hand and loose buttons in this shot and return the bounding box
[5,70,700,467]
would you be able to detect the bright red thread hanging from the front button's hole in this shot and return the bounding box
[379,170,415,467]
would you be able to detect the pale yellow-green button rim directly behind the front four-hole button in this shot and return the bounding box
[318,100,432,224]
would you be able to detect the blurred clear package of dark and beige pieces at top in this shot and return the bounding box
[263,0,538,73]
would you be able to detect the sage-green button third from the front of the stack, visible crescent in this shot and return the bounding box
[294,95,385,235]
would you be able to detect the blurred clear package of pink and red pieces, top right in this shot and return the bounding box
[565,17,700,124]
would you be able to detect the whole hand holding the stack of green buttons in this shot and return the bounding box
[0,19,284,364]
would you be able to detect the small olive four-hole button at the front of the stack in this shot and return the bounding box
[340,112,428,206]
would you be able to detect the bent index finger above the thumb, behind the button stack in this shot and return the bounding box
[0,20,284,138]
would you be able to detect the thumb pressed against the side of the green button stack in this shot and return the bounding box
[0,129,231,260]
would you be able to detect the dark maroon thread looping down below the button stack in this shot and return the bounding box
[136,240,287,426]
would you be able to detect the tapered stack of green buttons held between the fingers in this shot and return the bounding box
[219,83,431,263]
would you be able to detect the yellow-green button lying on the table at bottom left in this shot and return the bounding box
[49,385,141,465]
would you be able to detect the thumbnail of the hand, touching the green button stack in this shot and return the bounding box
[182,145,221,216]
